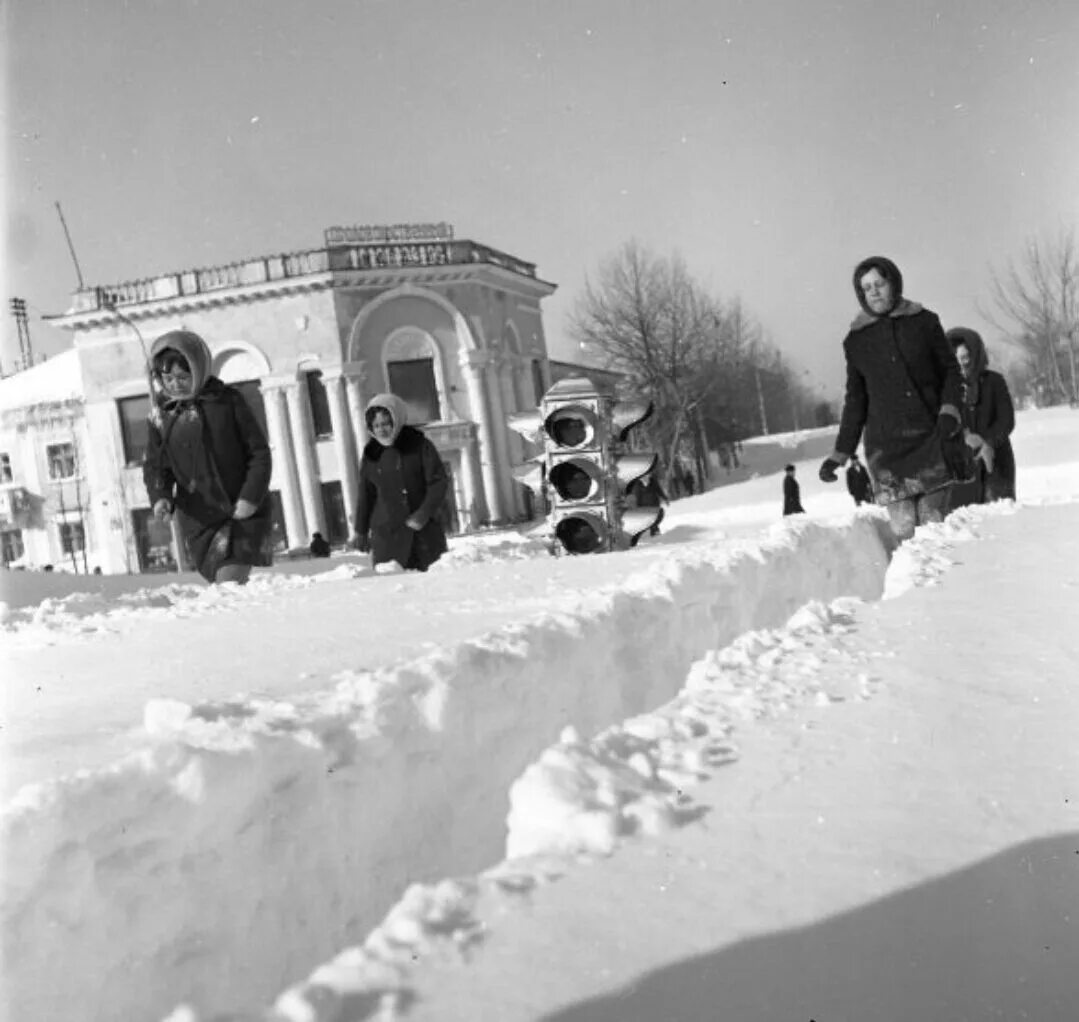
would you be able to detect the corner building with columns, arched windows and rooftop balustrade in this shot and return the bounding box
[5,224,555,572]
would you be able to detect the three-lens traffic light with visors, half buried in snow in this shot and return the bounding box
[508,377,664,554]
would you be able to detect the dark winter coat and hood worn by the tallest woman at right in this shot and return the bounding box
[835,263,961,504]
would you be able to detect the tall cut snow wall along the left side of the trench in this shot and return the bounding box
[0,515,891,1020]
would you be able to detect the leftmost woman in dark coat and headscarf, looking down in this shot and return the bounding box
[142,330,273,584]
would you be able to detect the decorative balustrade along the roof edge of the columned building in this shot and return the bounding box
[71,241,536,313]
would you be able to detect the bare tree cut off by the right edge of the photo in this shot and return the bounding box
[987,229,1079,406]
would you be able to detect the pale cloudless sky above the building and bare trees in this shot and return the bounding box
[0,0,1079,396]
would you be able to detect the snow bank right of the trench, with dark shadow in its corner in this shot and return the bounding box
[265,504,1079,1022]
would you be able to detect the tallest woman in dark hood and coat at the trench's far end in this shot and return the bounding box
[820,256,969,540]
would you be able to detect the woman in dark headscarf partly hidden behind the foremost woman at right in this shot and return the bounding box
[947,327,1015,504]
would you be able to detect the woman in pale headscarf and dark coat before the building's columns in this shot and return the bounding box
[354,394,449,571]
